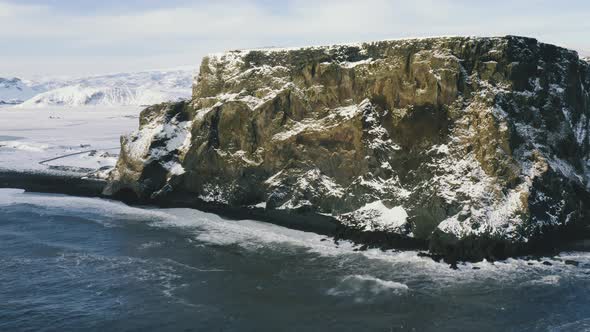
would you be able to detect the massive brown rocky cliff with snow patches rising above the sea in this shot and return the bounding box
[106,37,590,259]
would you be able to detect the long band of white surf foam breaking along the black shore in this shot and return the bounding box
[0,189,590,287]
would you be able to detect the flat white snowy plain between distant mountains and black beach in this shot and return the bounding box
[0,106,142,174]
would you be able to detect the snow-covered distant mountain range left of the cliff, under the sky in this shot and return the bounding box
[0,69,193,107]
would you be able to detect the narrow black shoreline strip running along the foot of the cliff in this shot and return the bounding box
[0,170,590,268]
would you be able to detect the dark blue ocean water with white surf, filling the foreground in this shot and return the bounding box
[0,189,590,331]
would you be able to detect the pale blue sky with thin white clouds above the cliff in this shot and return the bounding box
[0,0,590,78]
